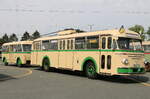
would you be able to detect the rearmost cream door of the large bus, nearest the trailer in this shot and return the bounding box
[31,41,41,65]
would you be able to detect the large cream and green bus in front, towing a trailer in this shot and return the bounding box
[31,29,145,78]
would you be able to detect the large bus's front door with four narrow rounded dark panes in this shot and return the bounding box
[100,36,112,74]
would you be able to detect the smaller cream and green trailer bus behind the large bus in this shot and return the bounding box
[2,41,32,66]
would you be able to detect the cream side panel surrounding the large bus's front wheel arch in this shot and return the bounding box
[73,51,100,73]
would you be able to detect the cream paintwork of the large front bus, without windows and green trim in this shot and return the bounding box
[31,30,144,75]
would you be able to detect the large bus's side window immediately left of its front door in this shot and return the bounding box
[87,36,99,49]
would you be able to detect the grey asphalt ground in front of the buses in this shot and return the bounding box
[0,64,150,99]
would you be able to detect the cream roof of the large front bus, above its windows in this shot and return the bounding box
[34,29,141,41]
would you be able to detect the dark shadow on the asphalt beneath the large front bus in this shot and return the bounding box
[35,68,149,84]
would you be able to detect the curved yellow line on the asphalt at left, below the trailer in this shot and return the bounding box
[0,68,32,81]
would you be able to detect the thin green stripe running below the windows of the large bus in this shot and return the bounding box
[32,49,144,53]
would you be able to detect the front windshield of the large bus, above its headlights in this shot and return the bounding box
[117,37,143,50]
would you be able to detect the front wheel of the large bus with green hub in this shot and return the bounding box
[85,61,97,79]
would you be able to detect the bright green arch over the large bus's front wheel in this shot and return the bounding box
[81,57,98,73]
